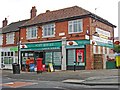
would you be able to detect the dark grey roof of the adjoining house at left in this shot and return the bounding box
[2,19,29,33]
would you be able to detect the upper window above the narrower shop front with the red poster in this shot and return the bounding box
[68,19,83,34]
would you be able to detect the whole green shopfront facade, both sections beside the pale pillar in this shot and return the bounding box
[20,40,90,70]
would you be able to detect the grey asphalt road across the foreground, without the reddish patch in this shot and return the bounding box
[2,77,119,90]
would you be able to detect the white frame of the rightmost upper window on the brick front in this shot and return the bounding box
[68,19,83,34]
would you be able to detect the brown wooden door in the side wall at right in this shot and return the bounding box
[94,54,103,69]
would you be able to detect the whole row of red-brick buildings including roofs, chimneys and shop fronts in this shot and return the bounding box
[0,6,116,70]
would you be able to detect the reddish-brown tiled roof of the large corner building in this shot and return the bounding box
[21,6,114,27]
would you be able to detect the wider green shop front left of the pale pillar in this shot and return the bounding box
[20,41,62,69]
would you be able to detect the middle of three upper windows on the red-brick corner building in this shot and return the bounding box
[42,24,55,37]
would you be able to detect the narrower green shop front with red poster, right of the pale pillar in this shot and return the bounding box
[66,40,90,70]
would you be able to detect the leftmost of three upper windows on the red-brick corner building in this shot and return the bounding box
[27,26,37,39]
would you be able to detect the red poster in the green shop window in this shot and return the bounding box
[76,49,84,63]
